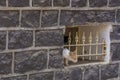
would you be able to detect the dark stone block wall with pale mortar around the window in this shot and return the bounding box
[0,0,120,80]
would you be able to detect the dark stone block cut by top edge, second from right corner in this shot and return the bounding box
[89,0,107,7]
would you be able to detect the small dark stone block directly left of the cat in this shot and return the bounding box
[48,49,64,68]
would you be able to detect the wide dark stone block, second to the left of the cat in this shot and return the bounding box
[15,50,47,73]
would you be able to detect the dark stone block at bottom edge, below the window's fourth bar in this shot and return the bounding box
[84,65,99,80]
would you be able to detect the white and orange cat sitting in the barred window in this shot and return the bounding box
[63,48,77,65]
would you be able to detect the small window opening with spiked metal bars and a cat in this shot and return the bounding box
[63,24,111,65]
